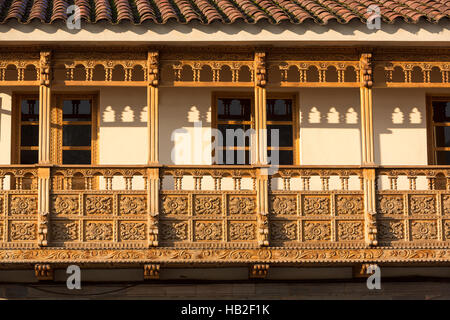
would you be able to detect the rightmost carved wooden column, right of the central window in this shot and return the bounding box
[359,53,377,246]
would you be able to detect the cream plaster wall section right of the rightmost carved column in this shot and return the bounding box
[373,88,450,165]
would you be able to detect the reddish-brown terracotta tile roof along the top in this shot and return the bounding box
[0,0,450,24]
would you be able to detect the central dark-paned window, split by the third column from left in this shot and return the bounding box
[213,93,298,165]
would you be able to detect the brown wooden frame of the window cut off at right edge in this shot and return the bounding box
[426,94,450,165]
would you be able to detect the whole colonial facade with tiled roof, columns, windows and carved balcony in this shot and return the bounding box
[0,0,450,279]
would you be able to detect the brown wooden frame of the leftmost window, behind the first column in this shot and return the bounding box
[11,92,100,166]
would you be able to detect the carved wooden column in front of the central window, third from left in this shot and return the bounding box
[251,51,270,246]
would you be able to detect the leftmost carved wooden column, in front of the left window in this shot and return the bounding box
[38,51,51,246]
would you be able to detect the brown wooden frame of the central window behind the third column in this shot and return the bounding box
[211,91,300,165]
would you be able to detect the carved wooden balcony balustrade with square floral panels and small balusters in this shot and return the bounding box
[0,166,450,265]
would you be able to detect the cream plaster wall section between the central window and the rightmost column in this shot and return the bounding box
[299,88,361,165]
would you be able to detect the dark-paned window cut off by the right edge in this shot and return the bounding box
[428,97,450,165]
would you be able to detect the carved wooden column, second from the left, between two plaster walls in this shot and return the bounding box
[147,51,160,247]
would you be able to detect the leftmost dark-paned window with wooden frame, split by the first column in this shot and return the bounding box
[15,95,97,164]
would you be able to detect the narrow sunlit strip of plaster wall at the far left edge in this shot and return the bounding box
[0,89,12,164]
